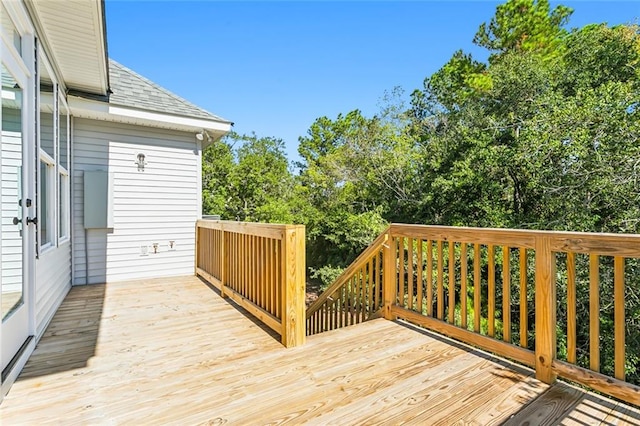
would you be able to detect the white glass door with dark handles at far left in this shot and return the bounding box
[0,57,35,369]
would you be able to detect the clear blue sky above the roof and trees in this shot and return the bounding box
[106,0,640,160]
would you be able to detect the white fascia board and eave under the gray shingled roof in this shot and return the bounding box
[68,96,231,137]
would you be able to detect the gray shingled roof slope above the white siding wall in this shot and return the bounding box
[109,59,230,123]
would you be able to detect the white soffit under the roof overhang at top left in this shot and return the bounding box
[30,0,108,95]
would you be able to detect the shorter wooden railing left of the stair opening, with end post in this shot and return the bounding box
[195,220,305,347]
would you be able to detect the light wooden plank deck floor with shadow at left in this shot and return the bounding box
[0,277,640,426]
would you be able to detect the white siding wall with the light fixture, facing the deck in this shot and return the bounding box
[72,119,200,284]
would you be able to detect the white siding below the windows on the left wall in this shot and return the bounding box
[35,245,71,338]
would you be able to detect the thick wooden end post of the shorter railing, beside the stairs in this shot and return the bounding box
[281,225,306,348]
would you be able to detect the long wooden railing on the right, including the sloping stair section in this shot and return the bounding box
[307,224,640,405]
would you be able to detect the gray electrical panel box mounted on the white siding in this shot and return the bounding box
[84,171,113,229]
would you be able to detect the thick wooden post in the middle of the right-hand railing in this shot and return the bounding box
[535,236,556,384]
